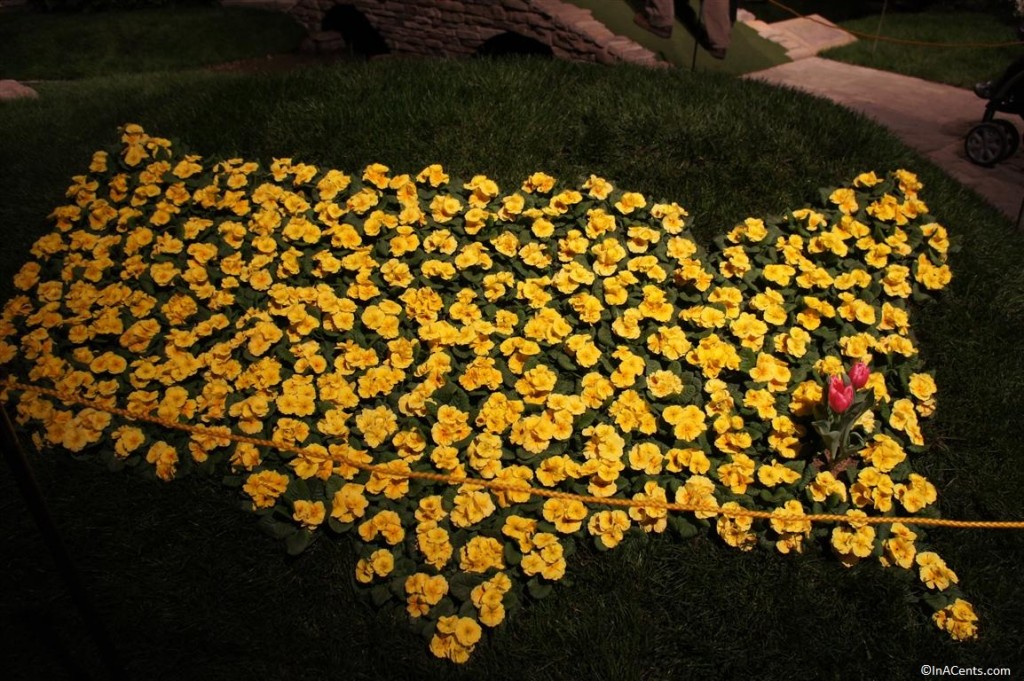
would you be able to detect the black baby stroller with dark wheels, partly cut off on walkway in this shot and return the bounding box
[964,57,1024,167]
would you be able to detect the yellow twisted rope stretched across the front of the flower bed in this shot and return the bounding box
[5,379,1024,529]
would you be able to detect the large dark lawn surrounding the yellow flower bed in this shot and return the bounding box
[0,53,1024,680]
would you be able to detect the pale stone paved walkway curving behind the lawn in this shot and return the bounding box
[745,13,1024,222]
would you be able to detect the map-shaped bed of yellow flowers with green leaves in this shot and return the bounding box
[0,125,976,663]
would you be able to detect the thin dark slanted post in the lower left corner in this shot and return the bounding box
[0,403,128,681]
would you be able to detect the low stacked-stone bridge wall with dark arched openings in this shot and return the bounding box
[282,0,668,66]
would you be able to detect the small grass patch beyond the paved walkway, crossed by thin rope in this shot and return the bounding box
[821,10,1024,88]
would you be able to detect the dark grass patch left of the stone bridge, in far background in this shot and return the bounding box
[0,5,305,80]
